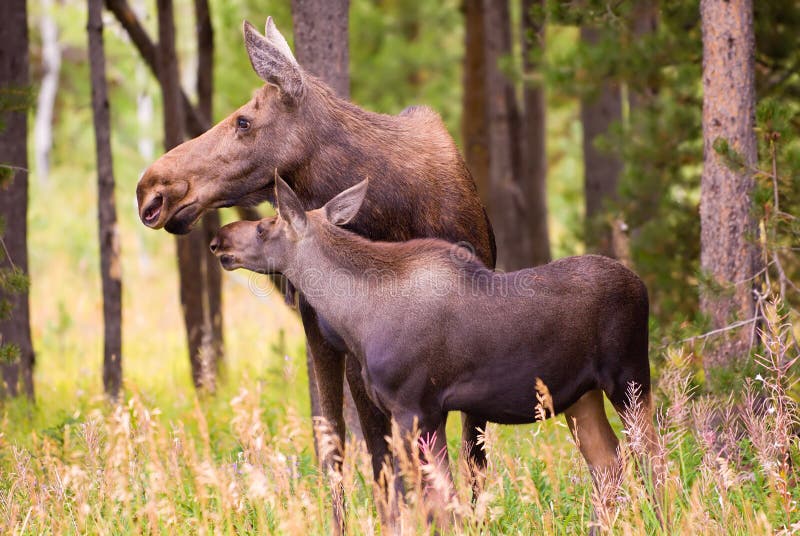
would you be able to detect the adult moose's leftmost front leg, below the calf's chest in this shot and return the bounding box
[299,298,345,534]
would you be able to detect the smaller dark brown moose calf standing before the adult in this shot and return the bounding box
[211,178,655,524]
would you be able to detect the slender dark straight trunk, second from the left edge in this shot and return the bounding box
[87,0,122,401]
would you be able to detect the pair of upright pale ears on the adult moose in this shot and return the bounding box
[243,17,303,103]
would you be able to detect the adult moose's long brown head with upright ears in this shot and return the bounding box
[136,17,307,234]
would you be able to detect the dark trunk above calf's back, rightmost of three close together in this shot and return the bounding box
[520,0,550,265]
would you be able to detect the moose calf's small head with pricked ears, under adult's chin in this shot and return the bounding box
[210,176,369,279]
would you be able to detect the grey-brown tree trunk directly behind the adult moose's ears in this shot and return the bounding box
[292,0,363,441]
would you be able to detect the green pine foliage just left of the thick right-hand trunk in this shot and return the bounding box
[543,0,702,321]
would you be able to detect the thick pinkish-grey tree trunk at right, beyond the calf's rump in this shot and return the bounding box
[700,0,761,379]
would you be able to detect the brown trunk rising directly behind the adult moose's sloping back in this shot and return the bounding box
[461,0,489,207]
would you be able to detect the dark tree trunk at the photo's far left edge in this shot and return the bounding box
[0,0,34,399]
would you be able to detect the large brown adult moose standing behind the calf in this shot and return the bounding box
[137,18,495,529]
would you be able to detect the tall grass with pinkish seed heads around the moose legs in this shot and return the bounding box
[0,304,800,534]
